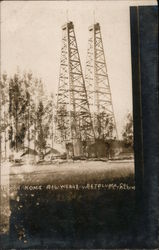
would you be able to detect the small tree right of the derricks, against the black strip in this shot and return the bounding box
[122,113,133,147]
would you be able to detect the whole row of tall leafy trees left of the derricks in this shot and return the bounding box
[0,72,54,160]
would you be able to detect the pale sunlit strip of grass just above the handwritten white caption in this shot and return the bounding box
[10,161,134,185]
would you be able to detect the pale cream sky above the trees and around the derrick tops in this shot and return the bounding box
[1,0,157,137]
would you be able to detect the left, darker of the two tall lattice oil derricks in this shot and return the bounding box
[56,22,94,155]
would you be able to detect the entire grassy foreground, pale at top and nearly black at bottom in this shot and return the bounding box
[0,161,138,249]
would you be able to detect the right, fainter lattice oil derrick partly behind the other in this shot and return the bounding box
[85,23,118,140]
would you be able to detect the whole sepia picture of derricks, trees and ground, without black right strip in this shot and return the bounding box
[0,0,157,249]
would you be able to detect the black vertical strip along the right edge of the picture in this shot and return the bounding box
[130,6,159,249]
